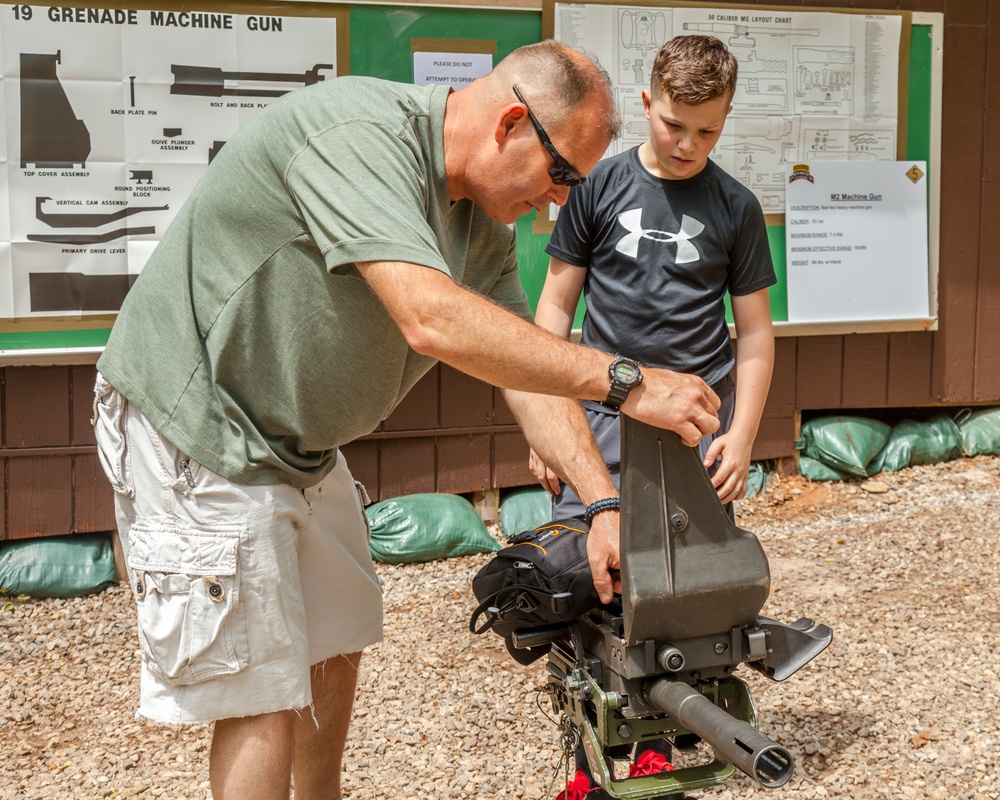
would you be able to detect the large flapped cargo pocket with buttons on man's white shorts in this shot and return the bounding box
[128,520,250,686]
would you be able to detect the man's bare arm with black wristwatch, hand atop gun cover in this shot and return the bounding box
[356,262,719,445]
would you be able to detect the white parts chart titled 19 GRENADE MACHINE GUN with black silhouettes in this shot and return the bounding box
[0,5,337,320]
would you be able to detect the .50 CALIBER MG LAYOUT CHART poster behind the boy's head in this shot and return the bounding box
[554,3,902,214]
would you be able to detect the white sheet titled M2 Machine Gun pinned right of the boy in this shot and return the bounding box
[785,161,931,322]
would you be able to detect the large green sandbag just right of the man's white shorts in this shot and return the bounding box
[365,494,500,564]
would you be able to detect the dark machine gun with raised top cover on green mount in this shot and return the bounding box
[512,415,833,800]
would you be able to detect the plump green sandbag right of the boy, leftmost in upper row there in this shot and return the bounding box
[795,417,892,478]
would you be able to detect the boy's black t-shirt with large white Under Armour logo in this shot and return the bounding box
[546,148,777,385]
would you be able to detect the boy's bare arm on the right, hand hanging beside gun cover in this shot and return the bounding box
[705,289,774,503]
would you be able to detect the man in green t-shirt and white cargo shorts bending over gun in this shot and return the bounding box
[94,42,718,800]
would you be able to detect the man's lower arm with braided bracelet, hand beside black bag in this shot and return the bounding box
[504,389,621,603]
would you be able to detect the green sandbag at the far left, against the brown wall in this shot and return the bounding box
[0,534,118,597]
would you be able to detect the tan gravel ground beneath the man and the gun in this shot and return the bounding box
[0,457,1000,800]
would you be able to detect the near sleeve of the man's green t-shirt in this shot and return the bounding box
[285,121,449,273]
